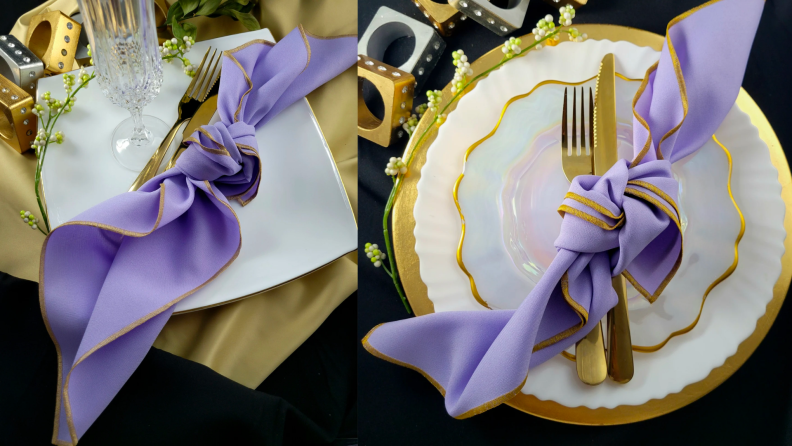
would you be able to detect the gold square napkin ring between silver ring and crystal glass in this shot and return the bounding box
[27,11,82,74]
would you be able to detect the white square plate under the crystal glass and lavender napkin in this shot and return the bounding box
[39,29,357,312]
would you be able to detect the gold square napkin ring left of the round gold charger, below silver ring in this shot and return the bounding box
[358,55,415,147]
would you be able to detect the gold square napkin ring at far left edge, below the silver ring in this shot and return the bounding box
[0,76,38,153]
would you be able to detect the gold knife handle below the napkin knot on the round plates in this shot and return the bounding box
[608,274,635,383]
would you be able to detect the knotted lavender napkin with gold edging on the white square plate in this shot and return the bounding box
[39,27,356,445]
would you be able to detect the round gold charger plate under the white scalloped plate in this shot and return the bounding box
[393,25,792,425]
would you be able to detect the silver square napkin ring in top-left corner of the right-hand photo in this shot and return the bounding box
[358,6,445,91]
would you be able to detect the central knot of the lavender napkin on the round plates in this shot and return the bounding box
[555,160,682,302]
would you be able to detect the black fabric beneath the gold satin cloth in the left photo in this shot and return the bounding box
[0,6,357,446]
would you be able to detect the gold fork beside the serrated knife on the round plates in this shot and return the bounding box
[561,87,608,386]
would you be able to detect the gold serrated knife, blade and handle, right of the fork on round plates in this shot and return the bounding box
[593,54,634,383]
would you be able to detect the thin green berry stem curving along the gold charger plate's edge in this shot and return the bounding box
[382,28,569,314]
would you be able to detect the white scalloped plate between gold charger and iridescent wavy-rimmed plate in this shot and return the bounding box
[414,40,786,409]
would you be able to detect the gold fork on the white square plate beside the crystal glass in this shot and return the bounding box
[129,47,222,191]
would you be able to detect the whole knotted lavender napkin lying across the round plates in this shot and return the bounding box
[363,0,764,418]
